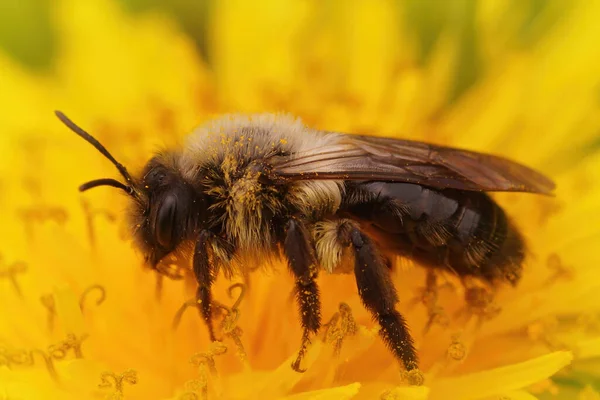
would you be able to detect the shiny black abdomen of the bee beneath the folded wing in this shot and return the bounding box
[340,182,524,284]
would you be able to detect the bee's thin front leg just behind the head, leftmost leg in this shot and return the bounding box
[194,230,217,342]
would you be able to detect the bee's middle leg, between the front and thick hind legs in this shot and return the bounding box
[283,219,321,372]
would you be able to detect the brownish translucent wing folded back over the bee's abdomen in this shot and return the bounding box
[271,134,555,194]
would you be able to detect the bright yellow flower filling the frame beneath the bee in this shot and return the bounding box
[0,0,600,400]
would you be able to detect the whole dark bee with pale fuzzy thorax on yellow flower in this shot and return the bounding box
[56,112,554,371]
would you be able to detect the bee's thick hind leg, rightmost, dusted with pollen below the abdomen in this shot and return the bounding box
[348,227,418,371]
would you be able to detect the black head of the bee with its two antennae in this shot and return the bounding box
[56,111,206,268]
